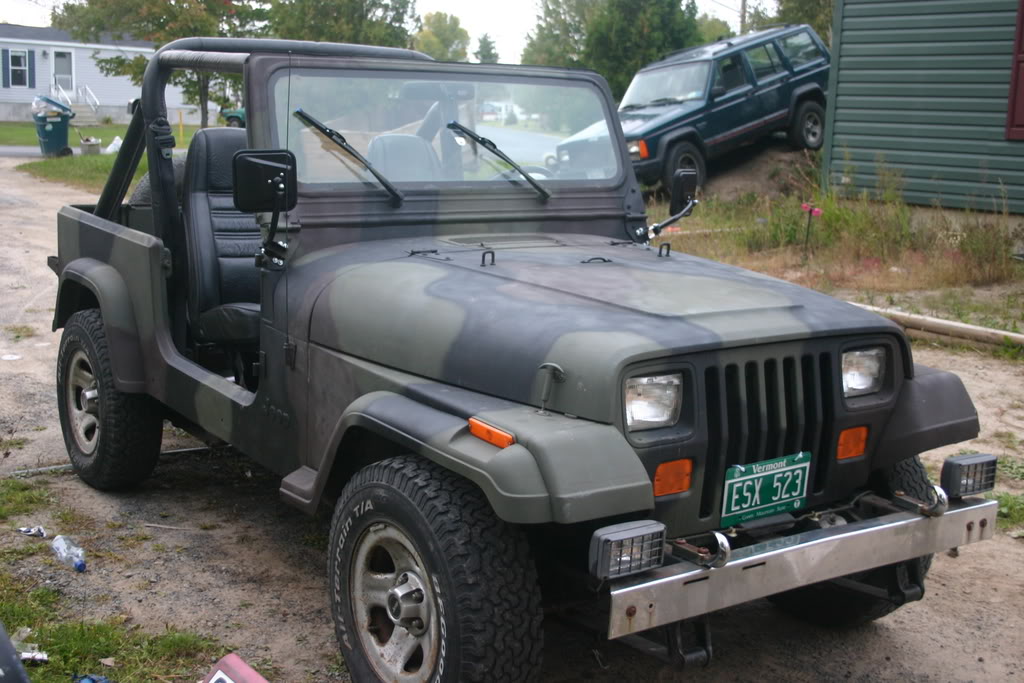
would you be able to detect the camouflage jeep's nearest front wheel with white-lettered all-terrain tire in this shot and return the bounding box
[328,456,543,681]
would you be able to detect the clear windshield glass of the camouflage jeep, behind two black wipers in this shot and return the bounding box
[270,68,621,188]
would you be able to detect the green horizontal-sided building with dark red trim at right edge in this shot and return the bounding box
[822,0,1024,214]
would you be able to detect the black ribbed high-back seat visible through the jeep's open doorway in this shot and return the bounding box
[182,128,261,344]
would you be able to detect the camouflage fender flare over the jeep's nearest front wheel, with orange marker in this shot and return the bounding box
[299,391,653,523]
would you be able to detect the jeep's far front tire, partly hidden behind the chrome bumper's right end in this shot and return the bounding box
[769,456,932,628]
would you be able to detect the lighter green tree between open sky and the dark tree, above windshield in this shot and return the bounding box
[521,0,604,67]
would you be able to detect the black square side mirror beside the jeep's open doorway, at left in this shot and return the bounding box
[232,150,299,214]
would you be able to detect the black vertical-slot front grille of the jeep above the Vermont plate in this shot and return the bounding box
[700,352,835,518]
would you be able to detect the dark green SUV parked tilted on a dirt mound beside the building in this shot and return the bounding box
[557,25,830,187]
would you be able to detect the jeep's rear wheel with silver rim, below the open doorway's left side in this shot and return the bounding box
[57,308,163,490]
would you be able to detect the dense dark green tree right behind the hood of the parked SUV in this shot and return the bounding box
[583,0,700,98]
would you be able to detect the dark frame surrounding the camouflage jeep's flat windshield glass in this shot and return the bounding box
[246,53,632,198]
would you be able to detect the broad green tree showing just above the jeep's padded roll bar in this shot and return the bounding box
[269,0,417,47]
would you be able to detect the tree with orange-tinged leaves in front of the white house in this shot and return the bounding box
[50,0,265,128]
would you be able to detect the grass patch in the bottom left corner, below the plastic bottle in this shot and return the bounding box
[0,571,225,683]
